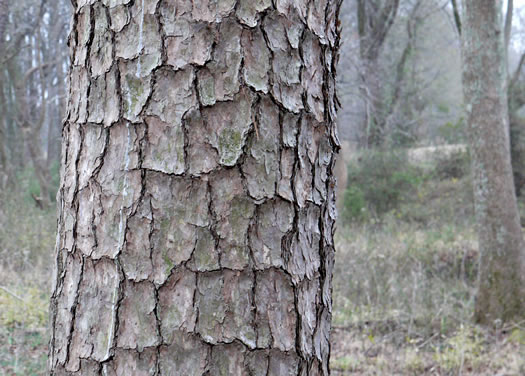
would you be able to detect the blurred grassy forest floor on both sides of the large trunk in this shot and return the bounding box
[0,157,525,376]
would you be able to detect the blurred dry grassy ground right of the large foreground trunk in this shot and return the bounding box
[331,163,525,376]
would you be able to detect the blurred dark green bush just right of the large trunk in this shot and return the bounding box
[343,151,422,222]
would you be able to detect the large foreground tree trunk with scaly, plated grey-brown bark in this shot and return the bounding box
[49,0,340,376]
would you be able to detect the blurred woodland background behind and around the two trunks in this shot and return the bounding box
[0,0,525,375]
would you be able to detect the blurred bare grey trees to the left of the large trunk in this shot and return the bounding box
[0,0,70,203]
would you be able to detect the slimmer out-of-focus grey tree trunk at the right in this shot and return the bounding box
[462,0,525,325]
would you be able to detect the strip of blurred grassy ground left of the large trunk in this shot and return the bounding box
[0,191,56,376]
